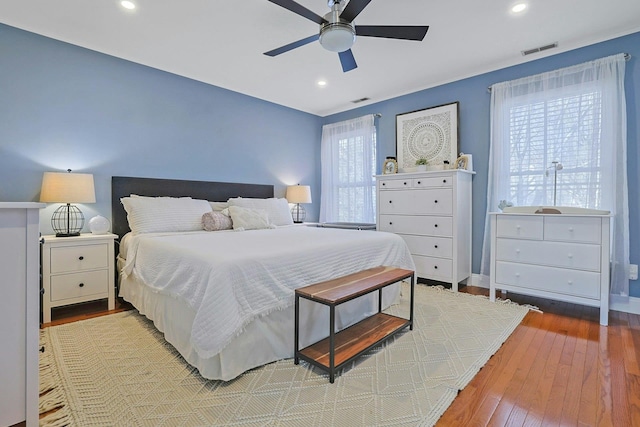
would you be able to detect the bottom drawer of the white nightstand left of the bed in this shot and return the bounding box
[50,270,109,301]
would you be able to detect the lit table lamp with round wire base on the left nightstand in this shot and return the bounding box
[40,169,96,237]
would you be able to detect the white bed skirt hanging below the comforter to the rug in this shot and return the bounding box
[118,259,400,381]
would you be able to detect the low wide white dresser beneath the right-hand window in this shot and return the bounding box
[490,213,610,325]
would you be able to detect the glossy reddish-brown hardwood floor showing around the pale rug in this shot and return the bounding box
[43,286,640,427]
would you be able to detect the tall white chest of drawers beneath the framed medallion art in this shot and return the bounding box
[376,169,474,291]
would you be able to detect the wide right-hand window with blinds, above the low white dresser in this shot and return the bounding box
[506,89,603,209]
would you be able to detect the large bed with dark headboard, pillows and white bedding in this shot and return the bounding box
[112,177,415,381]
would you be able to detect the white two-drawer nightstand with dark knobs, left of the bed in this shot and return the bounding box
[42,234,118,323]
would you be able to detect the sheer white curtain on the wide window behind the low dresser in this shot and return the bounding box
[481,54,629,296]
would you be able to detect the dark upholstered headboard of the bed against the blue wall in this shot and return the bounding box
[111,176,273,238]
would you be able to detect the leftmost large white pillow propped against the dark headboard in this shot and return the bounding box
[120,196,211,234]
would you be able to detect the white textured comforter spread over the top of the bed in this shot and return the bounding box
[122,226,415,358]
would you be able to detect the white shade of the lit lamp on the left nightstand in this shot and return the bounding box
[40,172,96,203]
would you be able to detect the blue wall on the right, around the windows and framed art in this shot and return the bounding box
[323,33,640,297]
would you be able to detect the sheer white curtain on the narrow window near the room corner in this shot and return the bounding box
[320,114,376,223]
